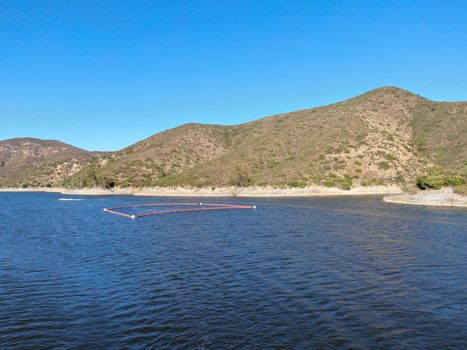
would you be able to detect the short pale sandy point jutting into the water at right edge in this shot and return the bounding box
[383,188,467,208]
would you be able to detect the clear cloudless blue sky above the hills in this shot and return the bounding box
[0,0,467,150]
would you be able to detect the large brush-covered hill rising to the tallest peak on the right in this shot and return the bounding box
[0,87,467,188]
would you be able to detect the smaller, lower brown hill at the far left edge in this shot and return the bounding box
[0,138,92,187]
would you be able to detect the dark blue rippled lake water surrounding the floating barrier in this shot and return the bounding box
[0,193,467,349]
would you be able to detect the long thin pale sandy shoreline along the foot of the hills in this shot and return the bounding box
[0,186,403,197]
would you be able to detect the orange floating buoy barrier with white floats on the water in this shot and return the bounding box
[104,202,256,220]
